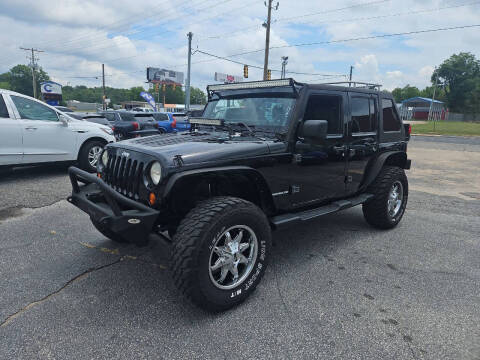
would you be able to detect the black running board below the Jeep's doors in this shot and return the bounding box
[270,194,373,228]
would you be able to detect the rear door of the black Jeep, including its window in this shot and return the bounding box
[346,92,379,195]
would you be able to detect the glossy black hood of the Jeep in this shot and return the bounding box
[112,133,273,166]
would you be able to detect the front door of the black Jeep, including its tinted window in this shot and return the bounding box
[290,91,347,207]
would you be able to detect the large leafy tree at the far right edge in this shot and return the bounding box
[431,52,480,112]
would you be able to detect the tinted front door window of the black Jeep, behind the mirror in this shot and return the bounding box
[303,95,343,135]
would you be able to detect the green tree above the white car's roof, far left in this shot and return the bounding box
[0,65,50,96]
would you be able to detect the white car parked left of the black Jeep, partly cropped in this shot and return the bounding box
[0,89,115,172]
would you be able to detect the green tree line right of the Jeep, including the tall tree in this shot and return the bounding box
[392,52,480,114]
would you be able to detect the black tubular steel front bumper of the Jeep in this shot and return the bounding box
[67,166,159,244]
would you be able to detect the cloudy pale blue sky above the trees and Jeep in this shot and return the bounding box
[0,0,480,90]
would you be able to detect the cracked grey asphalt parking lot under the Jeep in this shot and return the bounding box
[0,136,480,359]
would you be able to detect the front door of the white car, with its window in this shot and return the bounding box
[11,95,77,163]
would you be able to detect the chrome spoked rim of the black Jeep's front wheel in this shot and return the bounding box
[209,225,258,290]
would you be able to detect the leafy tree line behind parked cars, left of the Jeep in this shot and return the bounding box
[0,65,207,105]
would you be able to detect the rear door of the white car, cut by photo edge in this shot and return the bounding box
[0,94,23,165]
